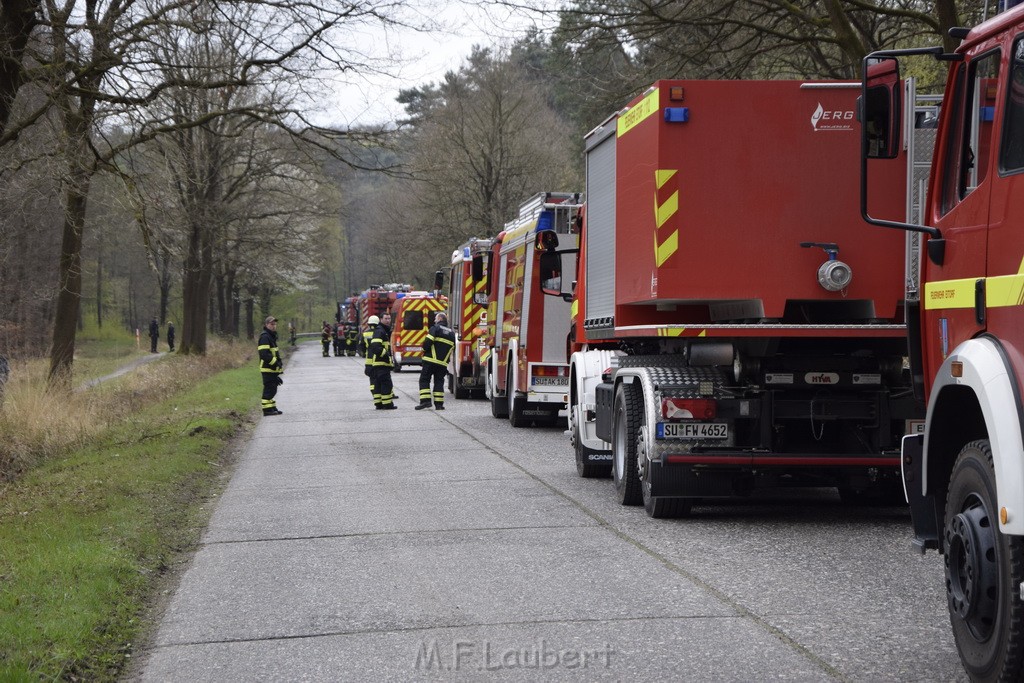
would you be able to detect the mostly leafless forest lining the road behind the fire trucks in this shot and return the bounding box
[0,0,978,382]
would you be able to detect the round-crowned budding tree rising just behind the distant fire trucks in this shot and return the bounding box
[389,49,582,278]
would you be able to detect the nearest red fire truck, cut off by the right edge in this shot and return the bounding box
[861,6,1024,681]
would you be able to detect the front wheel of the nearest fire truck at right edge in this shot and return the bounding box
[943,440,1024,681]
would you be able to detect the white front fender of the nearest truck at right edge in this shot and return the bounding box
[922,337,1024,536]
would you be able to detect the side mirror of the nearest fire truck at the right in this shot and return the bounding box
[858,57,903,159]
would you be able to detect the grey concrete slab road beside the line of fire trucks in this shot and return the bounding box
[141,344,966,681]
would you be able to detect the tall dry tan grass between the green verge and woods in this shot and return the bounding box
[0,340,253,481]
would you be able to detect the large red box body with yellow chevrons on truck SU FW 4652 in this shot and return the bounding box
[579,81,905,339]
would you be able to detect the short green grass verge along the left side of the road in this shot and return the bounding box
[0,364,259,681]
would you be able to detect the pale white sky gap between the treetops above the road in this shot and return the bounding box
[314,0,552,126]
